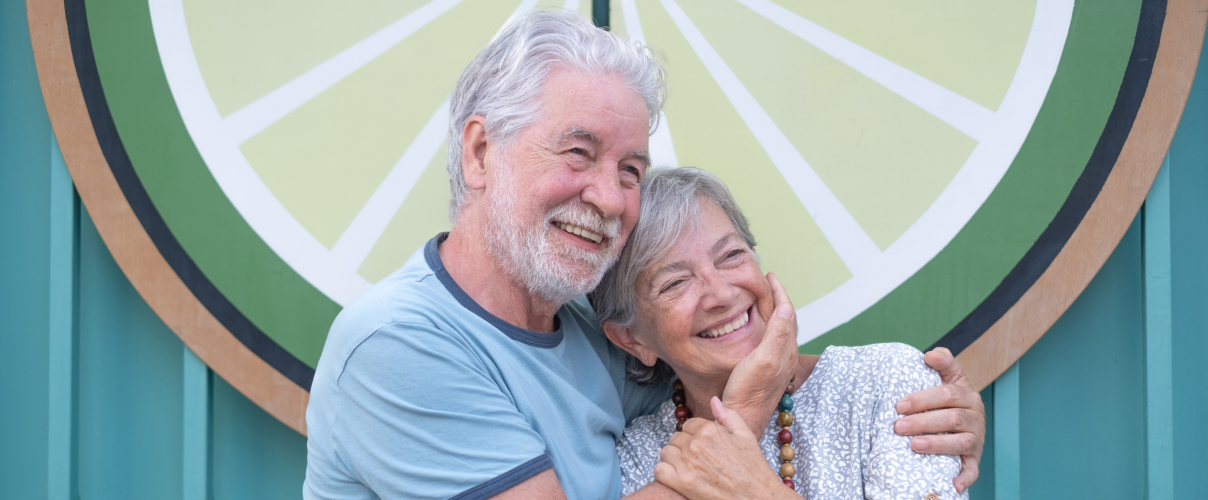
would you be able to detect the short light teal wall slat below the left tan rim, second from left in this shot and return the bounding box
[181,345,210,500]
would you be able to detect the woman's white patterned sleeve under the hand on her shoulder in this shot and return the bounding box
[864,344,969,500]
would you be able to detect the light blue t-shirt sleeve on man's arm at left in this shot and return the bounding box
[332,324,552,499]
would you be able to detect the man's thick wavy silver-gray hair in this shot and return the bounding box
[447,10,667,220]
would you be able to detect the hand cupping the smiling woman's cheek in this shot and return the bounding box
[721,273,797,429]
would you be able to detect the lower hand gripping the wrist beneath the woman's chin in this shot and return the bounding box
[655,397,801,500]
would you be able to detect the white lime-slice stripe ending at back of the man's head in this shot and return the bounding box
[331,99,449,273]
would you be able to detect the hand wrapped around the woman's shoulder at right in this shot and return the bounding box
[894,348,986,492]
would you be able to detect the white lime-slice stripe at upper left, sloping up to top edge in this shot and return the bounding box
[222,0,461,145]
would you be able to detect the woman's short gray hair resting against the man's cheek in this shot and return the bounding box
[587,167,755,384]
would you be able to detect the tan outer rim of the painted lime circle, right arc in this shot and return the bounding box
[957,0,1208,390]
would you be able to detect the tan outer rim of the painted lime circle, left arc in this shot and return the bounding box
[25,0,310,435]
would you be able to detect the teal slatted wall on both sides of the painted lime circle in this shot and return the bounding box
[0,1,1208,500]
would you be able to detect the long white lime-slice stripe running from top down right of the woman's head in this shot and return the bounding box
[661,0,881,277]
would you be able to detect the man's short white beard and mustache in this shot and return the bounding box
[484,161,621,304]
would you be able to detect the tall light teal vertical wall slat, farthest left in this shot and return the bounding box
[46,133,77,500]
